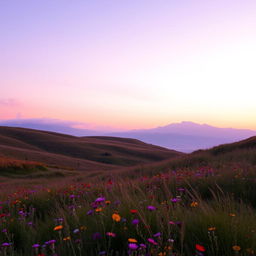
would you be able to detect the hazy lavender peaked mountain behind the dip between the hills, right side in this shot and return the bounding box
[107,122,256,152]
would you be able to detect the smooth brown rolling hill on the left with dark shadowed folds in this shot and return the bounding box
[0,127,182,173]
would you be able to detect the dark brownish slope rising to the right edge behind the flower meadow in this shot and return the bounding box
[120,136,256,177]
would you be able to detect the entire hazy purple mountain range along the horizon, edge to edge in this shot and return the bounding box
[0,119,256,153]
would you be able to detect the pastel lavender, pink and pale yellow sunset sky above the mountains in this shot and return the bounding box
[0,0,256,130]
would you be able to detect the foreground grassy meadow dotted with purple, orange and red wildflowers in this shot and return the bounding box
[0,153,256,256]
